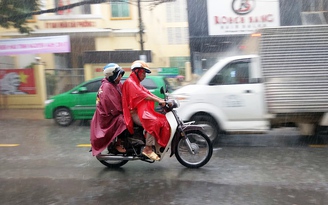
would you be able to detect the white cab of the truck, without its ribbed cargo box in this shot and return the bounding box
[172,55,269,140]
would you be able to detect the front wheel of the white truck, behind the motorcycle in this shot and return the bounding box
[191,114,220,142]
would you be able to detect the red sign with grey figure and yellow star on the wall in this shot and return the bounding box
[0,68,36,95]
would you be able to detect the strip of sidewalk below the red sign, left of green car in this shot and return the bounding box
[0,108,45,120]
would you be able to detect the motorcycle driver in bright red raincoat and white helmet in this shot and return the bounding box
[122,61,170,160]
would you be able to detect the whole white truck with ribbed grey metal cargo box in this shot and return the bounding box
[172,25,328,140]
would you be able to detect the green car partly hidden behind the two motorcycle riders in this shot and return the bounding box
[44,75,171,126]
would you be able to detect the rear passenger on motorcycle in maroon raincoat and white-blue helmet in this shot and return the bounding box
[90,63,127,156]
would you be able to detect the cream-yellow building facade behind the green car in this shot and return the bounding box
[0,0,190,77]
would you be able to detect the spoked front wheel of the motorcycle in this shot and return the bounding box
[175,130,213,168]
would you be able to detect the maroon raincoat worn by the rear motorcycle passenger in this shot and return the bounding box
[90,78,126,156]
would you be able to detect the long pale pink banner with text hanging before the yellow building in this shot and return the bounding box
[0,35,71,56]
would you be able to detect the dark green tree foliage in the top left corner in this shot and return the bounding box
[0,0,40,33]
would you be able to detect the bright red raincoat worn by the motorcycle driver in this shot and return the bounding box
[122,72,170,147]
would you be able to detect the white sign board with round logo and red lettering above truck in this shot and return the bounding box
[207,0,280,36]
